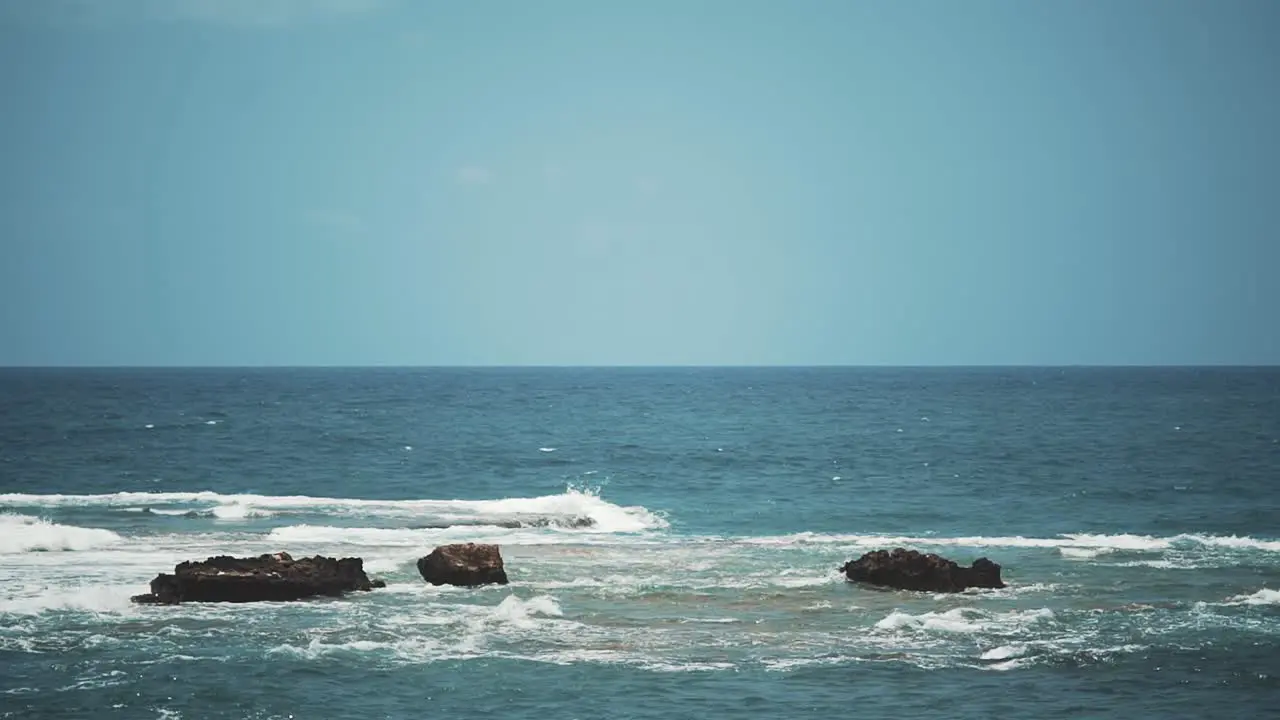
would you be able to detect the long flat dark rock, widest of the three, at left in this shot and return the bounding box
[133,552,385,605]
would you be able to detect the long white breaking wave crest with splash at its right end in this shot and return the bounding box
[0,488,668,533]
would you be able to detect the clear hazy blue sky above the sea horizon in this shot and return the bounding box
[0,0,1280,365]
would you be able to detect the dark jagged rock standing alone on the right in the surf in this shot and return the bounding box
[840,547,1005,592]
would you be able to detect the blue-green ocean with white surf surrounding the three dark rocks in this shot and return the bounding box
[0,368,1280,720]
